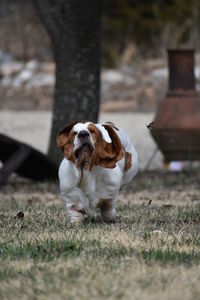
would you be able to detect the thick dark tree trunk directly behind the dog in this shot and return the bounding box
[35,0,101,163]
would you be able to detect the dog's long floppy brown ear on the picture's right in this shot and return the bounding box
[96,124,124,169]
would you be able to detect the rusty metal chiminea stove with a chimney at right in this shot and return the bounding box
[151,50,200,162]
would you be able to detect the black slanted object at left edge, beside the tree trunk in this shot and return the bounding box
[0,134,57,186]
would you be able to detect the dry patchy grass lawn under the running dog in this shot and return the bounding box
[0,171,200,300]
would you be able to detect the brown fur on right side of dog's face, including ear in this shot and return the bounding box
[88,123,124,169]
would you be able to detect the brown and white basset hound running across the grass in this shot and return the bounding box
[57,122,138,223]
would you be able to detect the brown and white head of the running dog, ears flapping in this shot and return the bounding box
[57,122,124,170]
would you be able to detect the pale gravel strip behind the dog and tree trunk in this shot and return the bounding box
[0,111,162,169]
